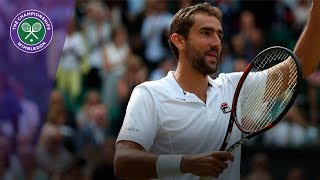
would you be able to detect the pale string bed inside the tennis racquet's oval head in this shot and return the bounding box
[236,49,298,133]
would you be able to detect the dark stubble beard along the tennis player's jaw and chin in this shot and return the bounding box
[186,42,218,75]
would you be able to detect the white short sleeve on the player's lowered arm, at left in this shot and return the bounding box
[116,85,158,151]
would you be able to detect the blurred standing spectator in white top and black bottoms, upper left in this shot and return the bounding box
[82,1,112,91]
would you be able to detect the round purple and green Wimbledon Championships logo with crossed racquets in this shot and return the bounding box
[10,9,53,53]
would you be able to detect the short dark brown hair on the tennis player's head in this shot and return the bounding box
[168,2,222,59]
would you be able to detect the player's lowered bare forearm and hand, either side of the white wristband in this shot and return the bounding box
[114,141,233,179]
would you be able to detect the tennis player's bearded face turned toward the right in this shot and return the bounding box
[186,14,223,75]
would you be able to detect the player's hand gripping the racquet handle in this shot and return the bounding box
[180,151,234,178]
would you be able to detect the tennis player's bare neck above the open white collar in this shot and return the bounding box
[173,66,208,102]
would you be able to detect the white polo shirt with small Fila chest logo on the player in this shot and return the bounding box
[117,71,242,180]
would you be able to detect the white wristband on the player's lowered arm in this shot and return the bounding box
[156,155,183,178]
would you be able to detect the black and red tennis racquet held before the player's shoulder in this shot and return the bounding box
[220,46,302,152]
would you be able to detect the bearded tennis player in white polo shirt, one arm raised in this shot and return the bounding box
[114,0,320,180]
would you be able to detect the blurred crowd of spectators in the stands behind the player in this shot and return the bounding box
[0,0,320,180]
